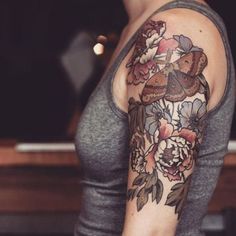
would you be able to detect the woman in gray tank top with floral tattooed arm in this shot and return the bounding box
[75,0,234,236]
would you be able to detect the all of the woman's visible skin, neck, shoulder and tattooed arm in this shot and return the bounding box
[110,0,227,236]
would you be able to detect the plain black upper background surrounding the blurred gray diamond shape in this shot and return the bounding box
[0,0,236,141]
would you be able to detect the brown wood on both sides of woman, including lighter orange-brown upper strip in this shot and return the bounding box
[0,143,236,213]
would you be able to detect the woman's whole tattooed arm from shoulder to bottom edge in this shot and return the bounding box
[122,8,227,236]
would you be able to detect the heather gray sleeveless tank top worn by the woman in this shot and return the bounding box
[75,0,235,236]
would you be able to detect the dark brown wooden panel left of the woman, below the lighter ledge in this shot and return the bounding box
[0,167,81,213]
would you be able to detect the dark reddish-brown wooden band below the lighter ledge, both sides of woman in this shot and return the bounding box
[0,164,236,213]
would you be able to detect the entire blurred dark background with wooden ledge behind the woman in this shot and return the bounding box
[0,0,236,236]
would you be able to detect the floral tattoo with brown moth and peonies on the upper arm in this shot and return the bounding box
[127,20,209,219]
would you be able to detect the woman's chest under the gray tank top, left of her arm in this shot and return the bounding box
[75,84,129,181]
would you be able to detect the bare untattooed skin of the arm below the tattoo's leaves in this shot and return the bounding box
[122,166,178,236]
